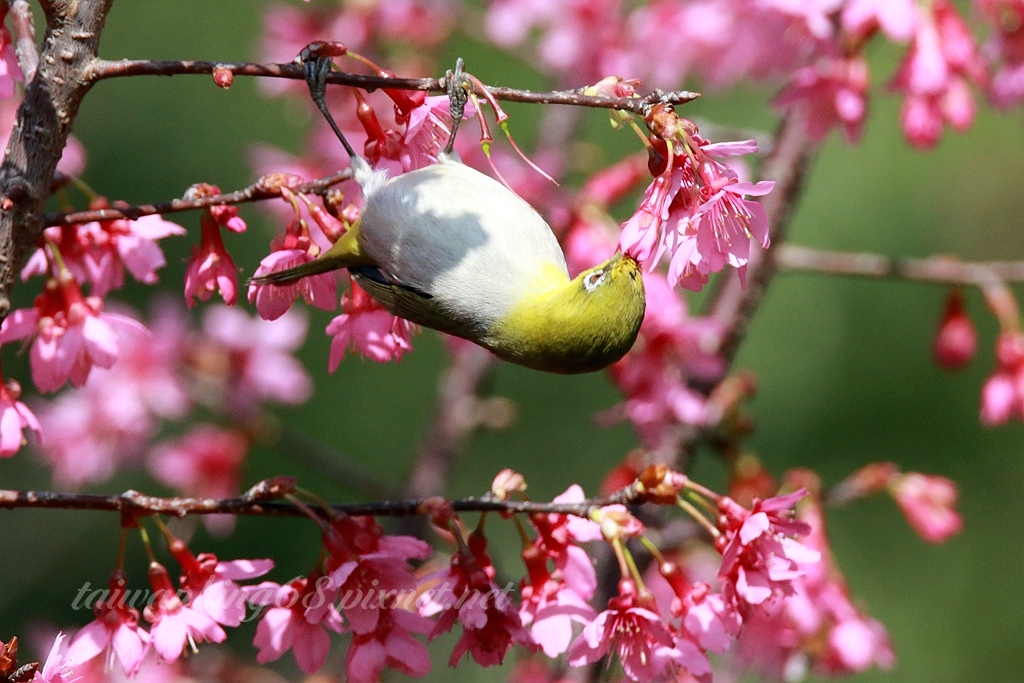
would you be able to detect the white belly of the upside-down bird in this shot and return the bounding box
[360,161,568,325]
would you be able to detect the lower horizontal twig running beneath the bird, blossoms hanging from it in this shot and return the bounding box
[0,488,635,517]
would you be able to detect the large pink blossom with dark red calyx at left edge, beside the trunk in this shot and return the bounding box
[0,270,150,391]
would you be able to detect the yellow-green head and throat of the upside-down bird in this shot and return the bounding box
[481,253,646,374]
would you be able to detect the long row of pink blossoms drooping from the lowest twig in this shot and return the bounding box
[9,458,958,683]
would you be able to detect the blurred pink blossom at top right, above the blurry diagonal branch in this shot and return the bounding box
[773,56,869,142]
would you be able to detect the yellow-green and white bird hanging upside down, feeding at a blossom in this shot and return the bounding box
[253,53,645,374]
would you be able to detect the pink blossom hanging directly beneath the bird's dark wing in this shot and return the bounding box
[326,281,416,373]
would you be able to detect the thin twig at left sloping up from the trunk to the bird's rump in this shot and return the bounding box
[43,169,352,225]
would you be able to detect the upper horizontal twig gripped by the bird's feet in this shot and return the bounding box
[87,59,700,114]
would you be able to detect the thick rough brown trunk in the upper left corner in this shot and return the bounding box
[0,0,113,318]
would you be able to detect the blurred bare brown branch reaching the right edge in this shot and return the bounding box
[775,245,1024,287]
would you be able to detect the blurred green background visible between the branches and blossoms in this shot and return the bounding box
[0,0,1024,683]
